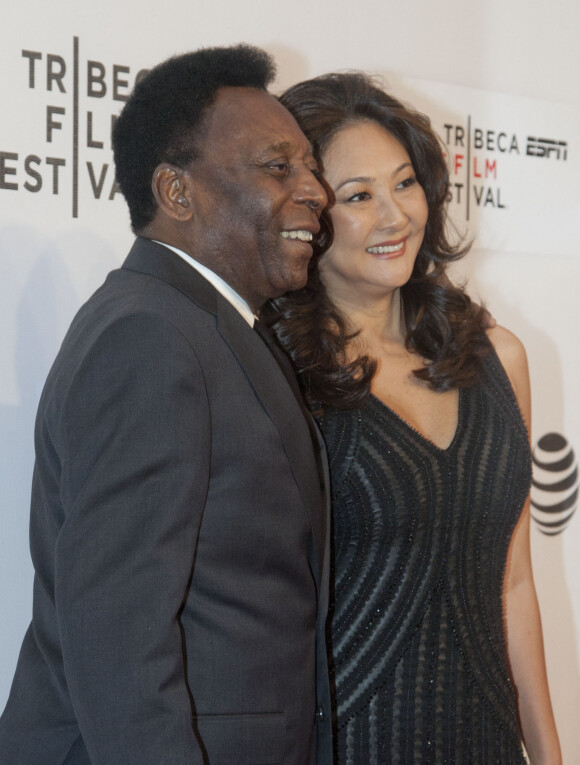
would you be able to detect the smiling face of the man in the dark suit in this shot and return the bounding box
[187,88,327,310]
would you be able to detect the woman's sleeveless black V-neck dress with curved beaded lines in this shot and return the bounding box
[321,353,530,765]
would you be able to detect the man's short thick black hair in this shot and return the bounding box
[113,45,276,232]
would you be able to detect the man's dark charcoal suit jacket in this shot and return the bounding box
[0,239,331,765]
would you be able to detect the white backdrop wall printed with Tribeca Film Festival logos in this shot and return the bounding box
[0,0,580,765]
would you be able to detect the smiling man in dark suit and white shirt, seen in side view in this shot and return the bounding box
[0,46,331,765]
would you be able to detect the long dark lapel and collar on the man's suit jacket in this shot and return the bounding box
[123,238,328,583]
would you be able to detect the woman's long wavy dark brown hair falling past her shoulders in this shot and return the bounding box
[262,72,489,410]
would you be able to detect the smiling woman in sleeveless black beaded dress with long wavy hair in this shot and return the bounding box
[269,73,561,765]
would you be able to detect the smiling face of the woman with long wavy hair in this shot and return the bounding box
[320,122,428,301]
